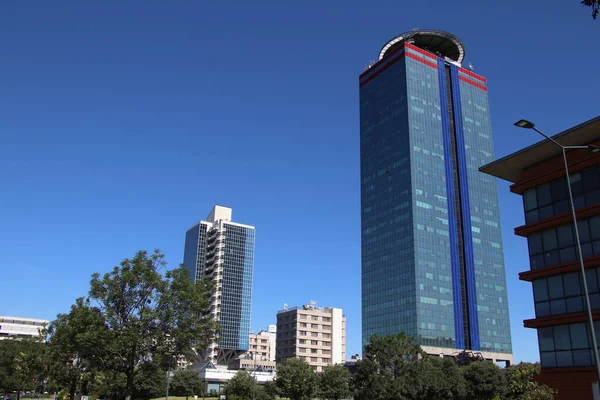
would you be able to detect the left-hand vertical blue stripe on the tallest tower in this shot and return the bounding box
[438,58,465,349]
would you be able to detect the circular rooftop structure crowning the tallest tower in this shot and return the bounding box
[379,29,465,63]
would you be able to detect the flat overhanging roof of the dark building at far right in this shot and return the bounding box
[479,116,600,183]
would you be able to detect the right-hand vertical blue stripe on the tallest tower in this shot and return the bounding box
[450,65,480,350]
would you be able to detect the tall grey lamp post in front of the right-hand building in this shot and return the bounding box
[514,119,600,390]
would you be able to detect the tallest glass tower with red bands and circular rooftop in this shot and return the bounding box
[359,30,512,363]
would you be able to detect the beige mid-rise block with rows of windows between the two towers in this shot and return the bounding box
[275,302,346,372]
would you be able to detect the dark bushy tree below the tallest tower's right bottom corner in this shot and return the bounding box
[461,361,508,400]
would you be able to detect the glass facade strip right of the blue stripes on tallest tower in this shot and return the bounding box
[459,75,512,353]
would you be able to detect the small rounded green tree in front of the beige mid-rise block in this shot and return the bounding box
[275,358,317,400]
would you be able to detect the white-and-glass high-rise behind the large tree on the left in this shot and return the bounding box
[183,205,255,364]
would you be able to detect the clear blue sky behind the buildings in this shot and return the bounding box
[0,0,600,361]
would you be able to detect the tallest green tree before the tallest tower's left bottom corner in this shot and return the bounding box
[353,332,427,400]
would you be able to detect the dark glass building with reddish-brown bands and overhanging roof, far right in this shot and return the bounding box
[481,117,600,400]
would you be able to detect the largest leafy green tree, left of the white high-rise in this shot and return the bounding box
[84,250,216,399]
